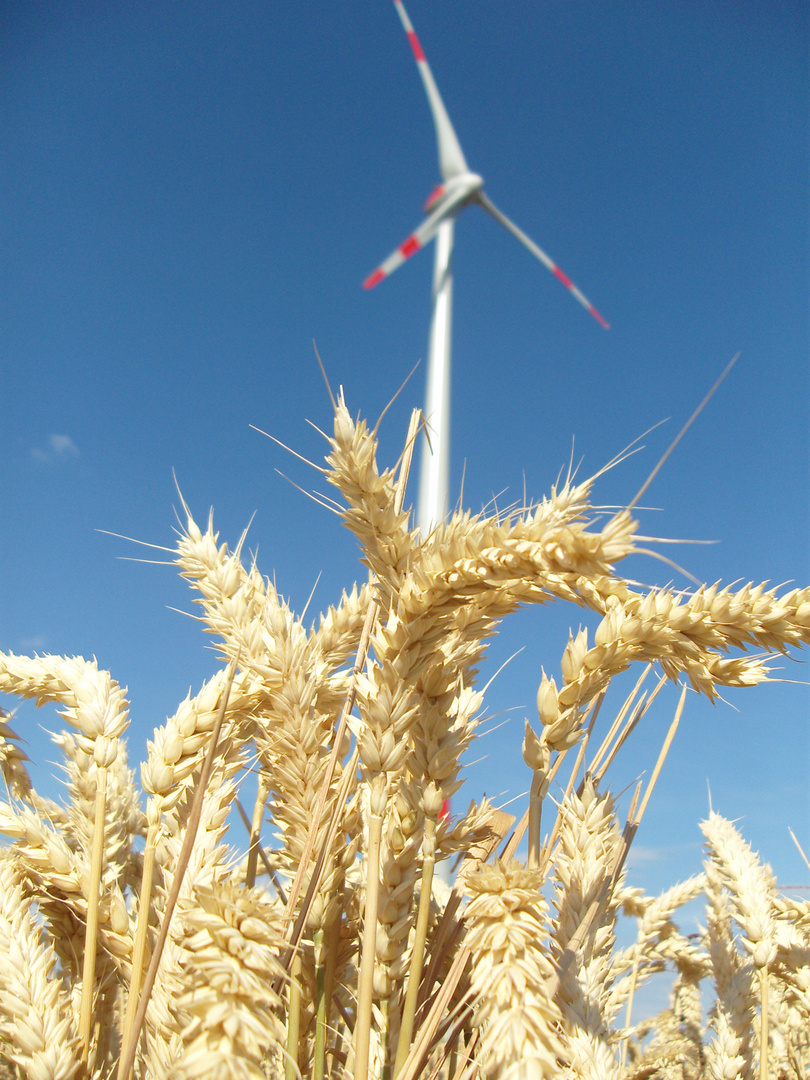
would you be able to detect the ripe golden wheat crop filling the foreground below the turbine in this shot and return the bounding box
[0,397,810,1080]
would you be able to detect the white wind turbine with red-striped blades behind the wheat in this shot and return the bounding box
[363,0,608,537]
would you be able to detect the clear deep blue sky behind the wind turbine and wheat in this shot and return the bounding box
[0,0,810,907]
